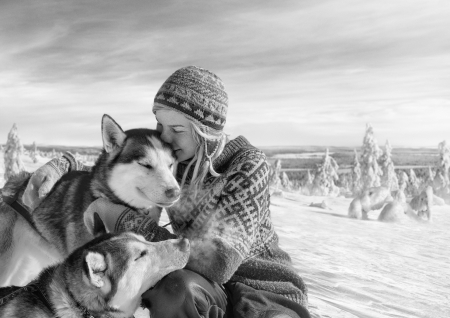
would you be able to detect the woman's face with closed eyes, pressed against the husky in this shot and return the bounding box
[155,109,197,162]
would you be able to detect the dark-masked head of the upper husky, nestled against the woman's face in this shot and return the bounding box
[93,115,180,209]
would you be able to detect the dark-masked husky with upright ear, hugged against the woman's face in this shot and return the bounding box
[0,115,180,286]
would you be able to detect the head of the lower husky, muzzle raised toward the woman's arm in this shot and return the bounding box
[62,232,190,317]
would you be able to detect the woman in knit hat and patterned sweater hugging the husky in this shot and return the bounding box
[24,66,309,318]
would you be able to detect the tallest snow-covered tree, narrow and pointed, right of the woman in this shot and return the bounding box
[361,124,383,190]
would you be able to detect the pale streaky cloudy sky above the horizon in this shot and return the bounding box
[0,0,450,148]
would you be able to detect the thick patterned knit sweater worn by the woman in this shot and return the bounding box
[74,136,307,306]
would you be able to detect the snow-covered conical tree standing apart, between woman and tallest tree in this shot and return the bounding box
[313,149,339,195]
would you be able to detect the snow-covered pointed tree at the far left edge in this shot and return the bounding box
[4,124,25,181]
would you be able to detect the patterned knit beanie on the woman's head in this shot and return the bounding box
[154,66,228,131]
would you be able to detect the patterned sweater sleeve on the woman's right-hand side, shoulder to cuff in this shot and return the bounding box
[187,151,269,283]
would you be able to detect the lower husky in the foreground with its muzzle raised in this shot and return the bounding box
[0,232,189,318]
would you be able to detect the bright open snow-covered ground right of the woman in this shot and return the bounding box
[0,156,450,318]
